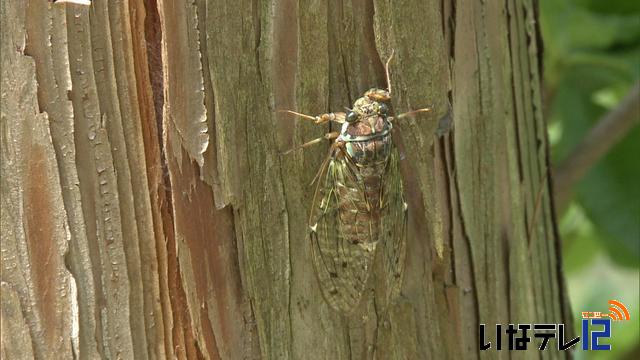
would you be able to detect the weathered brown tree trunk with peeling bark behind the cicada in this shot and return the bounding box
[0,0,571,359]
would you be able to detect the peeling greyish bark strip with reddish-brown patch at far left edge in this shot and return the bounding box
[0,2,78,359]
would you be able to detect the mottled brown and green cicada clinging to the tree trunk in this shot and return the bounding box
[284,53,429,314]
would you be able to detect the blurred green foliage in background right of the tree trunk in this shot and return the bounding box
[540,0,640,359]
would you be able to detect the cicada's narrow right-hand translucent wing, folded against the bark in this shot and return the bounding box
[375,149,408,307]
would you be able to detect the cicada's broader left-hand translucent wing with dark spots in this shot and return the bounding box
[309,157,376,314]
